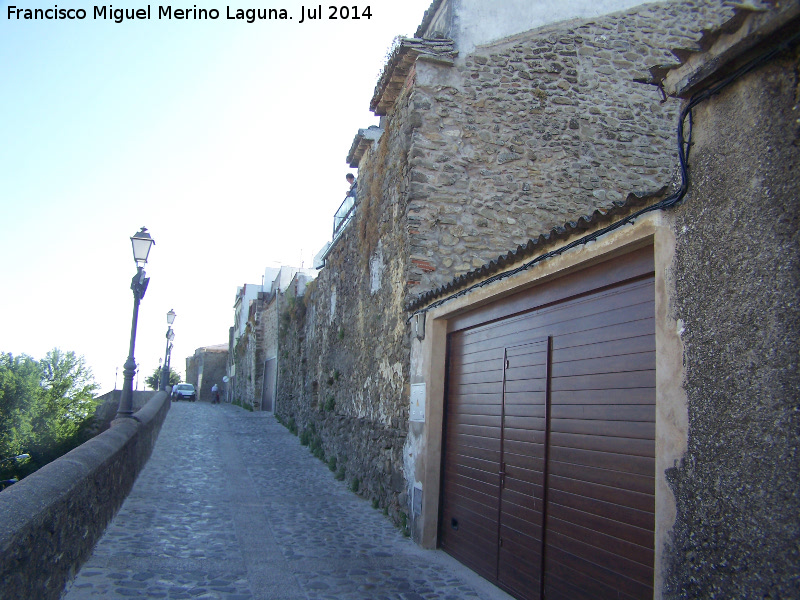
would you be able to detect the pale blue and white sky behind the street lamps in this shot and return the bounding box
[0,0,430,391]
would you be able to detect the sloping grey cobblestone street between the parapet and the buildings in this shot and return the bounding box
[65,402,509,600]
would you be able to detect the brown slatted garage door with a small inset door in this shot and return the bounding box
[440,249,655,600]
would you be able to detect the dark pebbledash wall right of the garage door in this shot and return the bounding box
[667,39,800,598]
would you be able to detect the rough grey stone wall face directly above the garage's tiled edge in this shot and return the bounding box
[408,1,744,293]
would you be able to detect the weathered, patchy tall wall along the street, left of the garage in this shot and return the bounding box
[277,77,411,522]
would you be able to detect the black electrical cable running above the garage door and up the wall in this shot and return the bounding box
[406,25,800,322]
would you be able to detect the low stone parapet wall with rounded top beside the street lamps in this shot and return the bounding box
[0,392,170,600]
